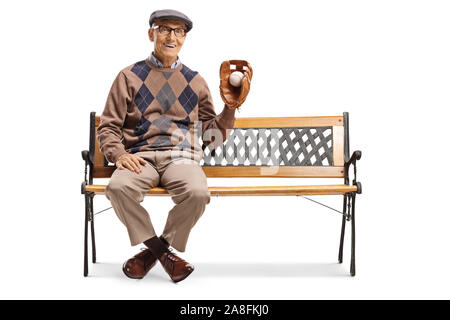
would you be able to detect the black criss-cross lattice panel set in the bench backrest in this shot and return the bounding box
[201,126,333,166]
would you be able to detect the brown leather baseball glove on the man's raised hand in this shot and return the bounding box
[220,60,253,109]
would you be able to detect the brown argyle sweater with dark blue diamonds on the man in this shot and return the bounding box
[97,58,235,163]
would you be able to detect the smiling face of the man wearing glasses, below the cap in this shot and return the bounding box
[148,20,186,60]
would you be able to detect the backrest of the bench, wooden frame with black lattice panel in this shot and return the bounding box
[89,112,349,178]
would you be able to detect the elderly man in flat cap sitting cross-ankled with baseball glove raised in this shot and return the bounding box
[98,10,252,282]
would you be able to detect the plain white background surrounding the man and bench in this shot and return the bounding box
[0,0,450,299]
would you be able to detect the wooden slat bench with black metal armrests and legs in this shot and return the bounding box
[81,112,361,276]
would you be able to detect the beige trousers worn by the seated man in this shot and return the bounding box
[105,150,210,252]
